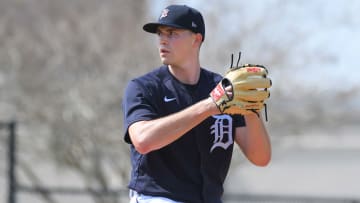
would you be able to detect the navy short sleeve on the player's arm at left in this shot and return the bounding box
[122,80,157,144]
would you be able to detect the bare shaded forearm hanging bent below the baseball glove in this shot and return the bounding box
[235,114,271,166]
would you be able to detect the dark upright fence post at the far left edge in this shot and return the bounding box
[8,121,17,203]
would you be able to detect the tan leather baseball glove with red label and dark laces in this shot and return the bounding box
[210,64,272,115]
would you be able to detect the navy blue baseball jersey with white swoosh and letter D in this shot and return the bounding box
[123,66,245,203]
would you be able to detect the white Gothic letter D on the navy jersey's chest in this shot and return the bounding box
[210,114,234,153]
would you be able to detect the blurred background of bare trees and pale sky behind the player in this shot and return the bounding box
[0,0,360,203]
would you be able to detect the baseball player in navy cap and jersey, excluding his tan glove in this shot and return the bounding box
[123,5,271,203]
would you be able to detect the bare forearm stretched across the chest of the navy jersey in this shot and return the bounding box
[129,98,219,154]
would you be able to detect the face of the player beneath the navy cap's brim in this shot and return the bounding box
[157,26,195,65]
